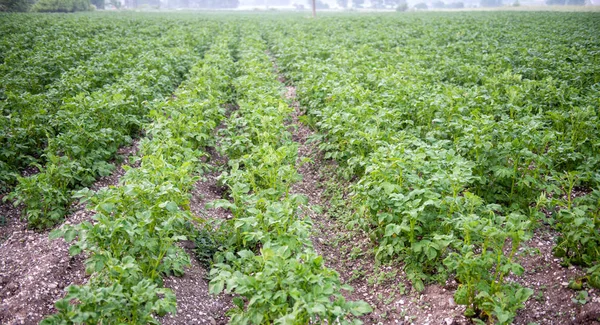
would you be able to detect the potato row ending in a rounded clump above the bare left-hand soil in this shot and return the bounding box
[8,22,216,229]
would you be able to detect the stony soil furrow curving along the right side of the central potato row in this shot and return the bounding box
[279,69,440,325]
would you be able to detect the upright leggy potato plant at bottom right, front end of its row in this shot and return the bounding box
[444,215,533,324]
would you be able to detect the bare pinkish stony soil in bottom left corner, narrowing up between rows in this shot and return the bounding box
[0,140,139,325]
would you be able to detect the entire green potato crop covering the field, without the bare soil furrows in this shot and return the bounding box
[0,10,600,324]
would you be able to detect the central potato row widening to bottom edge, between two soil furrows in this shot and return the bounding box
[205,26,371,324]
